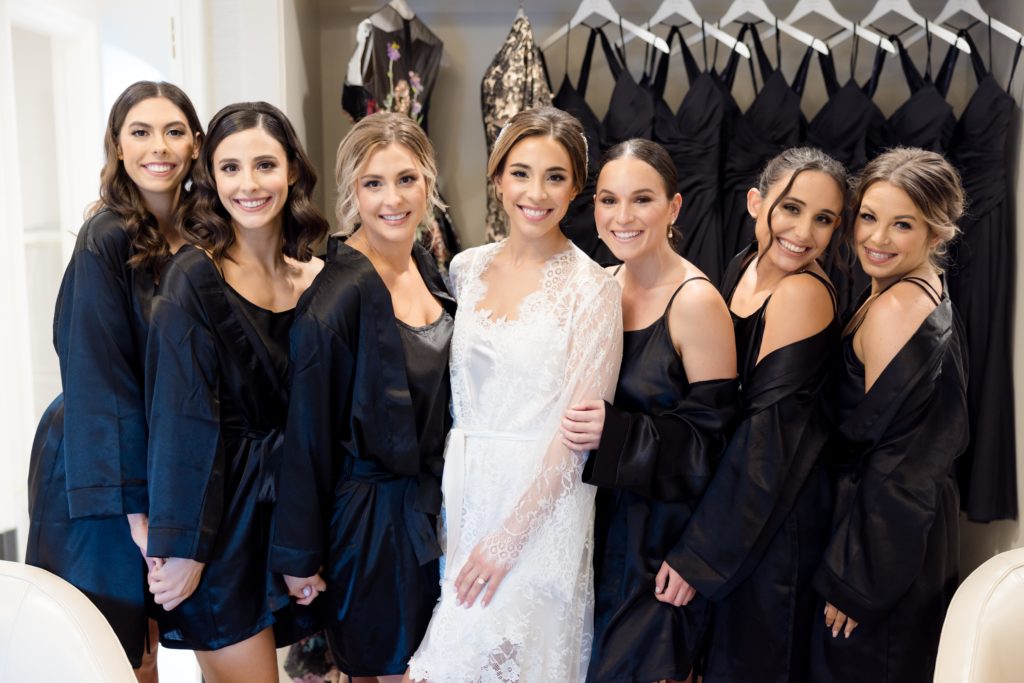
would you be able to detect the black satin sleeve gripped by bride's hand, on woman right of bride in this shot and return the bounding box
[583,379,739,502]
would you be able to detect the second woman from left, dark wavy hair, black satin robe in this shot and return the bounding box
[145,102,328,683]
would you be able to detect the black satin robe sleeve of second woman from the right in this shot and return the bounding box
[667,333,837,600]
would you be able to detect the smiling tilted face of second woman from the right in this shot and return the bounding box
[746,170,843,272]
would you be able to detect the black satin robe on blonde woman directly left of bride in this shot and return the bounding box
[270,238,455,676]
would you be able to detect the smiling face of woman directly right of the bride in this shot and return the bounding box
[594,157,682,261]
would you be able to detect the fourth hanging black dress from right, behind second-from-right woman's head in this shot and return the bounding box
[722,25,813,269]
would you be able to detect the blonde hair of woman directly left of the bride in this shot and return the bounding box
[334,112,444,234]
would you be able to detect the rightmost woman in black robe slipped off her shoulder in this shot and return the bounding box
[811,148,968,683]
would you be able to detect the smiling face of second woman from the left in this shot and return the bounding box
[213,128,294,235]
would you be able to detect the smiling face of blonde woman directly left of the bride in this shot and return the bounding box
[355,142,427,243]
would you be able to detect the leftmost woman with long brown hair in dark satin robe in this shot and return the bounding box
[26,81,203,680]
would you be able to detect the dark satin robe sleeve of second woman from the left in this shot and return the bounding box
[145,262,225,562]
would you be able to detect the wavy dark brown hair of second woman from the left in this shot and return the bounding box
[178,102,329,261]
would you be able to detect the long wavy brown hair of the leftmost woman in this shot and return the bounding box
[86,81,203,272]
